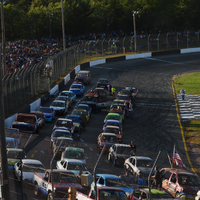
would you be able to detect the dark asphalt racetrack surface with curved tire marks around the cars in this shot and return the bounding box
[10,53,200,200]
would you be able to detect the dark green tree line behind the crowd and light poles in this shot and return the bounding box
[1,0,200,40]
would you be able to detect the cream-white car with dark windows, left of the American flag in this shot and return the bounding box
[124,156,155,180]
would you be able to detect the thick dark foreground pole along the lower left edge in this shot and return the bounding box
[0,27,10,200]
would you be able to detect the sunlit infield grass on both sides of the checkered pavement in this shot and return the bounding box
[174,73,200,150]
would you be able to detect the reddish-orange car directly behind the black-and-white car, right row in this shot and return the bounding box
[97,133,119,153]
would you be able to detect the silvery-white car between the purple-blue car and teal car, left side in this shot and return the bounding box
[50,100,68,115]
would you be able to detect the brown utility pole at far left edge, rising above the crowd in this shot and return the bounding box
[1,0,6,76]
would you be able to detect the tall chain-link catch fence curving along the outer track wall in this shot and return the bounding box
[3,31,200,116]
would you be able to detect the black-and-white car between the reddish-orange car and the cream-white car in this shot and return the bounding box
[108,144,135,167]
